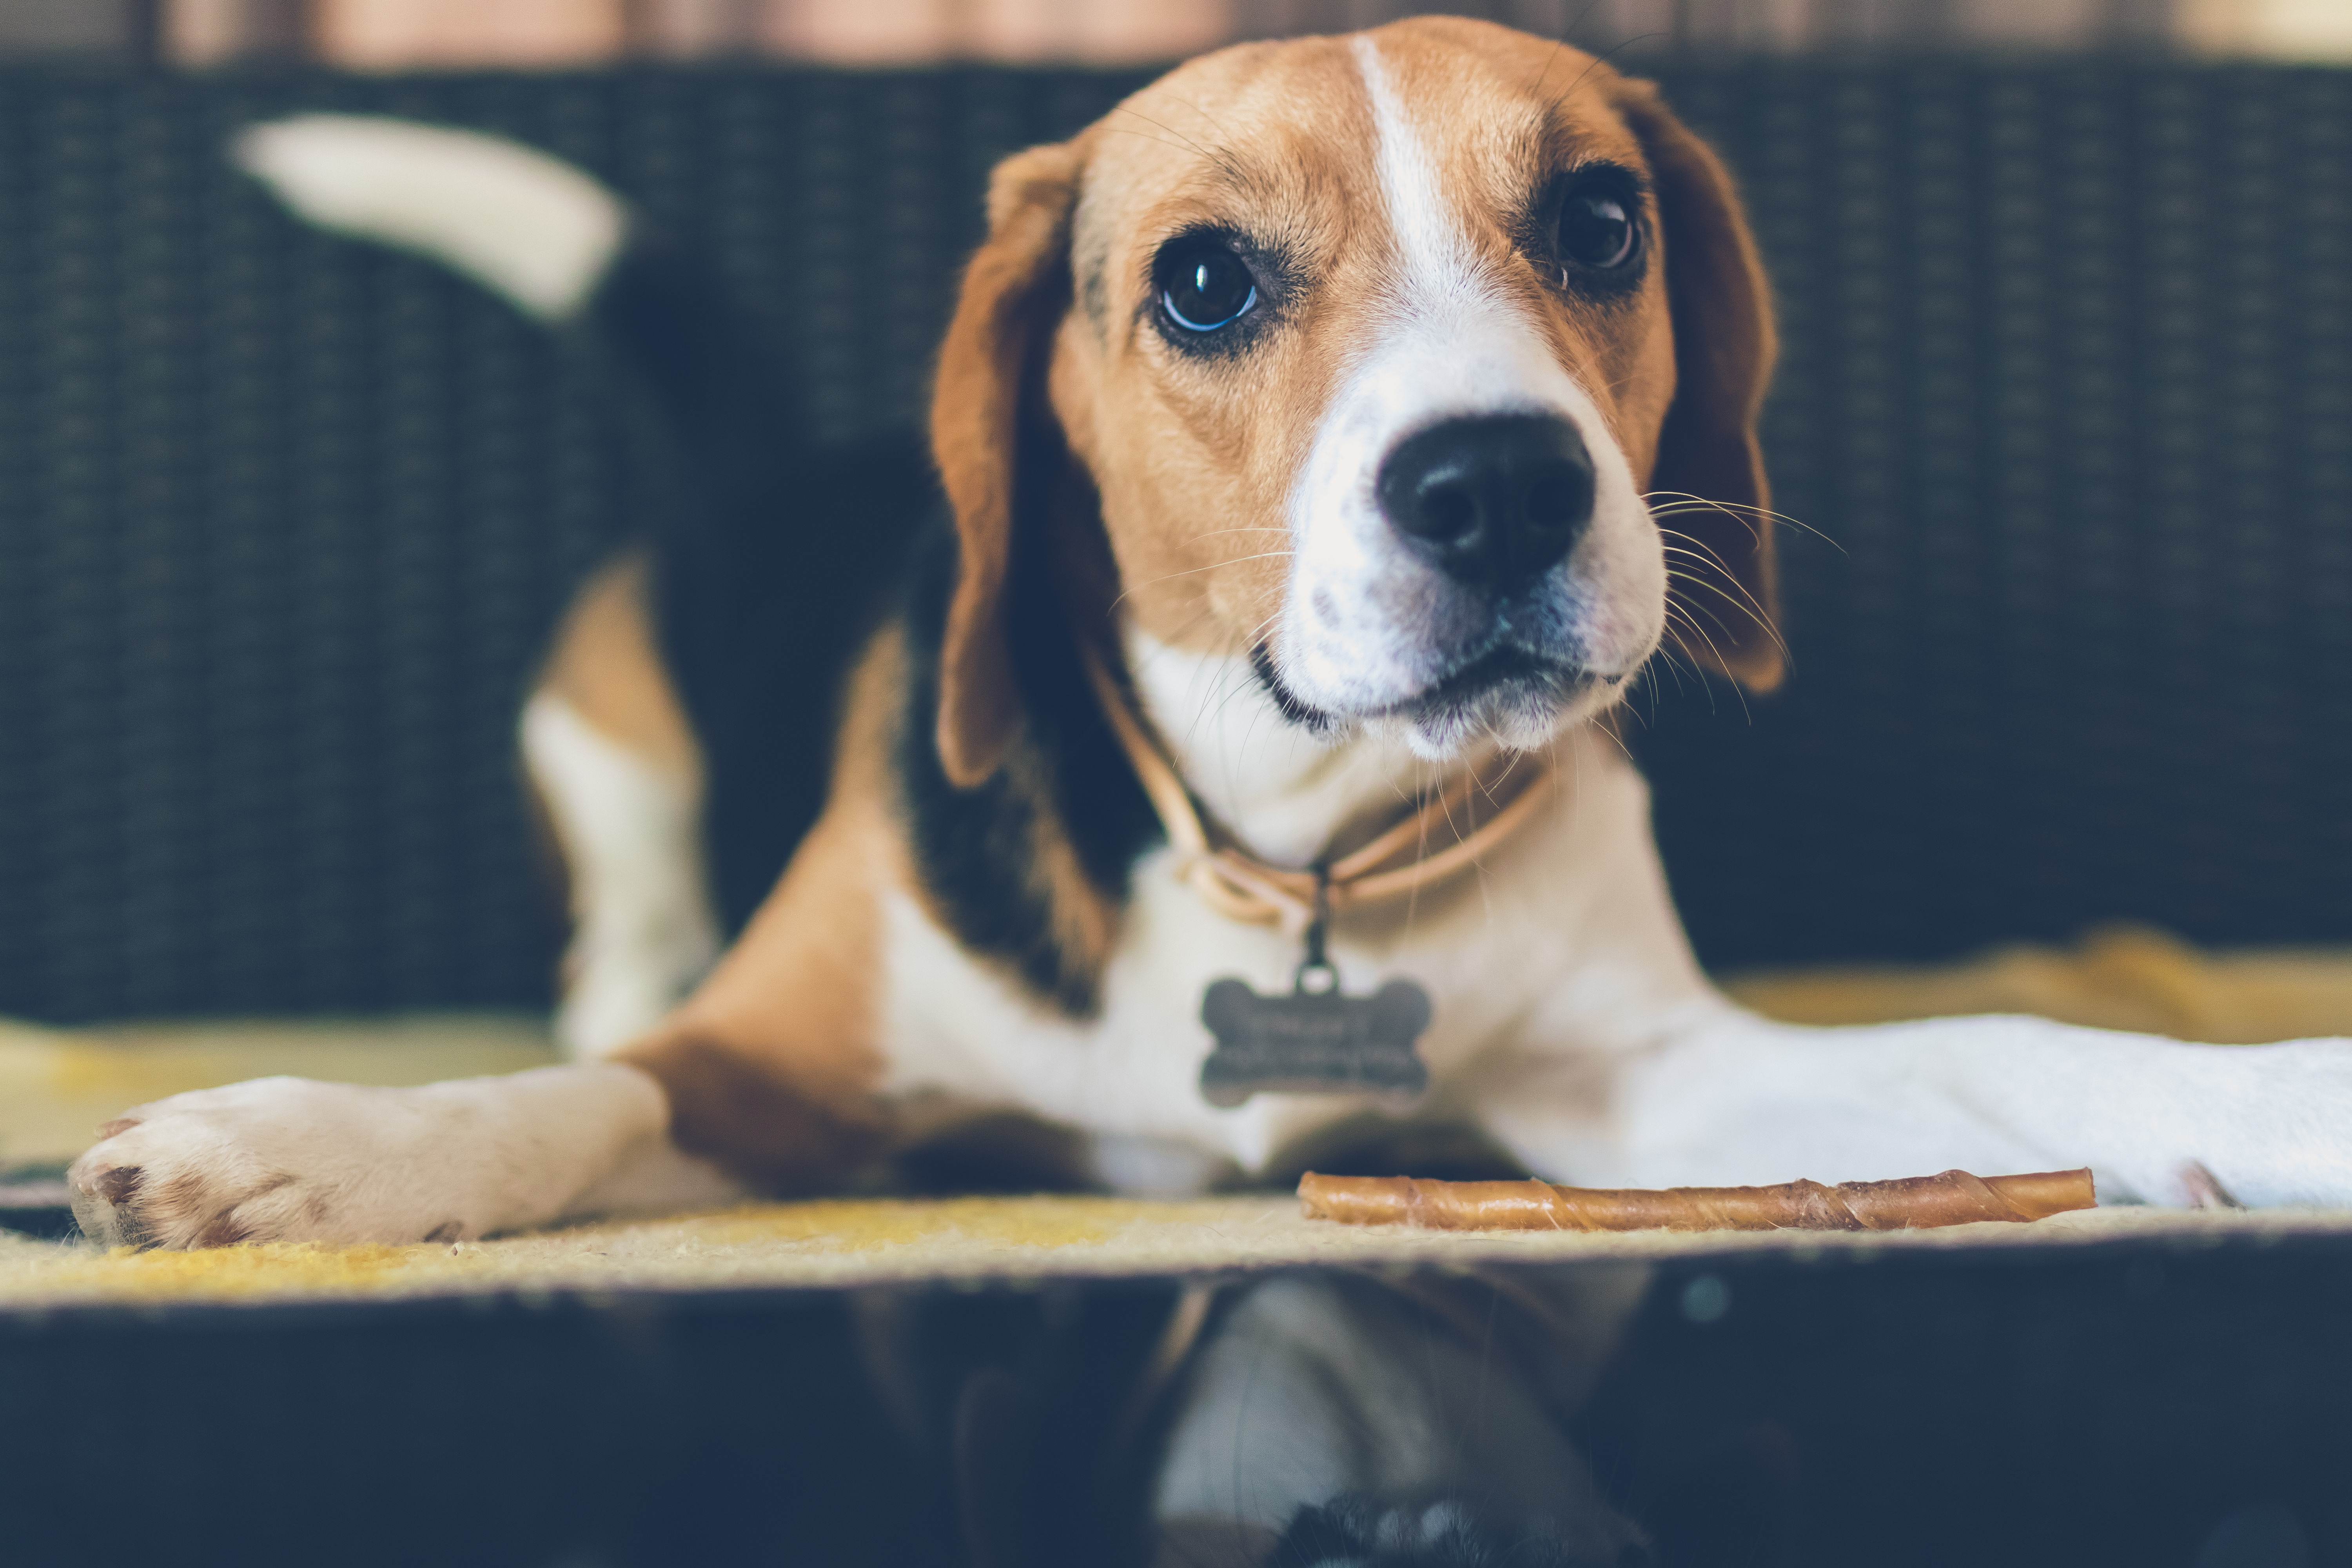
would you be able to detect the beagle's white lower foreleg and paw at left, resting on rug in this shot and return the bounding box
[66,1063,734,1246]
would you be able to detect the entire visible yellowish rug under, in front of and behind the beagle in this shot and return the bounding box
[14,929,2352,1307]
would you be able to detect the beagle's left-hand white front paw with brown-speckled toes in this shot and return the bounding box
[66,1079,466,1248]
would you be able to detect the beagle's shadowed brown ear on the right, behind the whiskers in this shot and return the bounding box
[1613,82,1783,691]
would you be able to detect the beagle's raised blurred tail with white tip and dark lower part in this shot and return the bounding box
[228,115,804,491]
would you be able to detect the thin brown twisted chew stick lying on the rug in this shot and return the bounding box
[1298,1171,2098,1229]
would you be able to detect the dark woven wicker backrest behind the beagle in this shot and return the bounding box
[0,61,2352,1018]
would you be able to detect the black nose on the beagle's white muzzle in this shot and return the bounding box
[1378,414,1592,592]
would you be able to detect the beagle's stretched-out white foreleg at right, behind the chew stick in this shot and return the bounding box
[1479,1009,2352,1206]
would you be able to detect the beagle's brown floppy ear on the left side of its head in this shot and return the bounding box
[931,141,1084,790]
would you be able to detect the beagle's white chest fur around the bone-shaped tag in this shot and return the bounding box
[882,682,1710,1185]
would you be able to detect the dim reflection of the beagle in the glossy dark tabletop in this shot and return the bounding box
[861,1265,1665,1568]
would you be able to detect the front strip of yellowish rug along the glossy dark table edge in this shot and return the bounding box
[0,1194,2352,1309]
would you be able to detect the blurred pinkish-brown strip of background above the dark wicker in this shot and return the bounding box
[0,0,2352,71]
